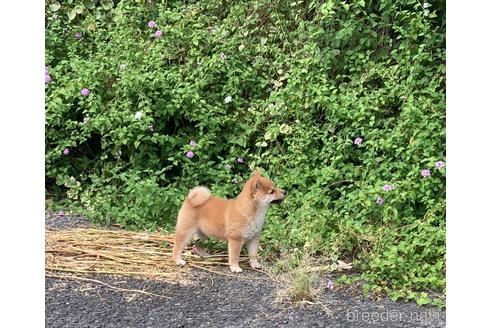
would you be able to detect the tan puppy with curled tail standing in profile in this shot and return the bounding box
[173,170,286,272]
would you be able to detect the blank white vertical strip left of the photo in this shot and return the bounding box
[0,1,45,327]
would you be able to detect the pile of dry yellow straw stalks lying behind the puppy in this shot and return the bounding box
[45,228,256,280]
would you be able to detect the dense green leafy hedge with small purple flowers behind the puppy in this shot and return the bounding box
[45,0,445,304]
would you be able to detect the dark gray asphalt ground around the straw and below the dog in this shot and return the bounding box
[45,215,446,328]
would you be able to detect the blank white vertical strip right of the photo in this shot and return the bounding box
[446,1,492,328]
